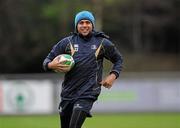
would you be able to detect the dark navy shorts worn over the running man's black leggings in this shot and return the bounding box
[59,99,94,117]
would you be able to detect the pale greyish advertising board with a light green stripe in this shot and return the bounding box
[93,78,180,112]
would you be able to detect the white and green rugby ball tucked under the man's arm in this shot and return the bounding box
[56,54,75,72]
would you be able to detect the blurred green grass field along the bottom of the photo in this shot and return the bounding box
[0,113,180,128]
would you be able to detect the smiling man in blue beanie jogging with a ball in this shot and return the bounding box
[43,11,122,128]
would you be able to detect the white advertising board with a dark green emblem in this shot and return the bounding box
[0,80,53,114]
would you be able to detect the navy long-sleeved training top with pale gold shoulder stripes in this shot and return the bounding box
[43,32,123,100]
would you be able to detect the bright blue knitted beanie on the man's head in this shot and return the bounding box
[75,11,95,30]
